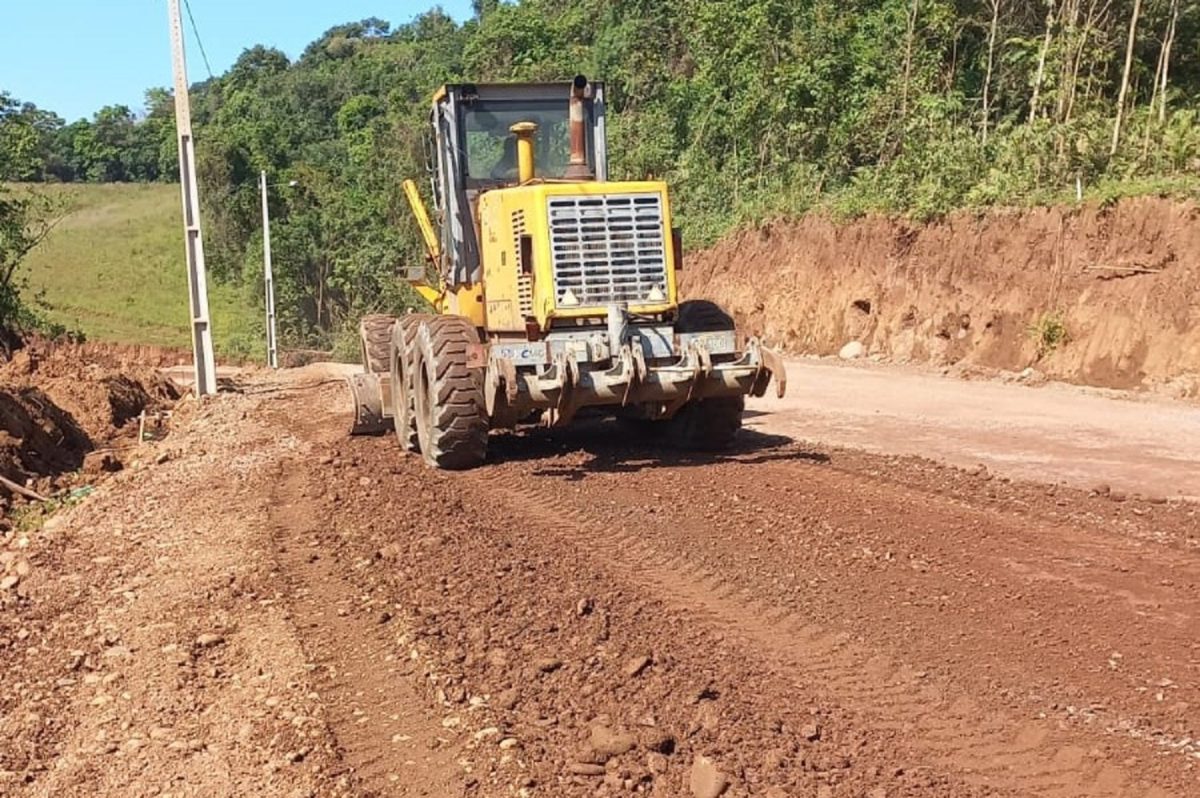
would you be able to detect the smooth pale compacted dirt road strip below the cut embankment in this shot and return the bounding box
[748,359,1200,500]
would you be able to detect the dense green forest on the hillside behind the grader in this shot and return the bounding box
[0,0,1200,344]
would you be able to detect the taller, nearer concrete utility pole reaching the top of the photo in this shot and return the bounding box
[167,0,217,396]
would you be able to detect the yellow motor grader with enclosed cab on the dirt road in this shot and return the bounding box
[350,77,784,469]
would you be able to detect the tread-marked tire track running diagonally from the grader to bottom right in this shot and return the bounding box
[476,478,1174,798]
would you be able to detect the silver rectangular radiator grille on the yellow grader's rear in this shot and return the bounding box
[548,193,667,307]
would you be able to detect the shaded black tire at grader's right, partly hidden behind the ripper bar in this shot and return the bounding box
[667,300,745,451]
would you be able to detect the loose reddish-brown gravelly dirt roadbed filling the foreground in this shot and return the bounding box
[0,372,1200,798]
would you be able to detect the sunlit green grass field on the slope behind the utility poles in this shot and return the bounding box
[16,184,264,356]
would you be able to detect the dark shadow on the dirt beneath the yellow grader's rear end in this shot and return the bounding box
[487,419,829,481]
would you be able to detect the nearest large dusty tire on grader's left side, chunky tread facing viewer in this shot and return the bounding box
[413,316,488,470]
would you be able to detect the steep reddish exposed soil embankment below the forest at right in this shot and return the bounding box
[683,198,1200,396]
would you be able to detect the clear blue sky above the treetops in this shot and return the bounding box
[0,0,470,121]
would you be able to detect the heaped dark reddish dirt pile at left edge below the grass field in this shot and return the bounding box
[0,341,179,510]
